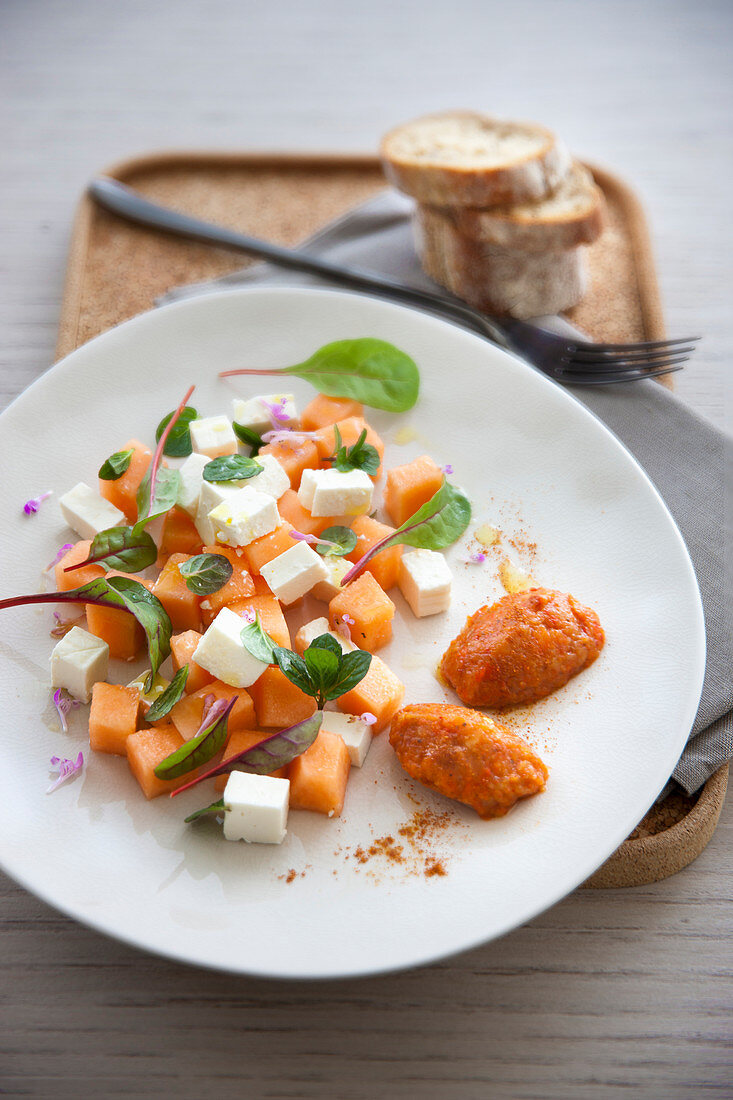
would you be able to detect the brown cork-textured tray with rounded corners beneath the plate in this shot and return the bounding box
[56,151,727,887]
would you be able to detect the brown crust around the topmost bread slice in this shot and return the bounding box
[380,111,571,207]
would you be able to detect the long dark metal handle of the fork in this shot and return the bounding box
[89,176,510,348]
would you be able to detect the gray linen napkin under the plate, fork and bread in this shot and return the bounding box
[161,191,733,794]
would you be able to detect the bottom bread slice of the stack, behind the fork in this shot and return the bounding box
[415,206,587,319]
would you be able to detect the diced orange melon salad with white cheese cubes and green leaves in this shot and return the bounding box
[0,339,471,844]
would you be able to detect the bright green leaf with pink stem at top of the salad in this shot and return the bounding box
[219,337,420,413]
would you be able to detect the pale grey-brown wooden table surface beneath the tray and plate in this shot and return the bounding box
[0,0,733,1100]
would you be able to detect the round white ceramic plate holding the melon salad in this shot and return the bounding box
[0,289,704,978]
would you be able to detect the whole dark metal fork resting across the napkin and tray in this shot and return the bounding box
[89,176,700,386]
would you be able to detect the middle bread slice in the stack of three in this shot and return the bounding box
[444,162,605,252]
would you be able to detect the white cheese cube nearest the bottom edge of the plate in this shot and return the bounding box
[223,771,291,844]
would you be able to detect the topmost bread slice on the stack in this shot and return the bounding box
[380,111,570,207]
